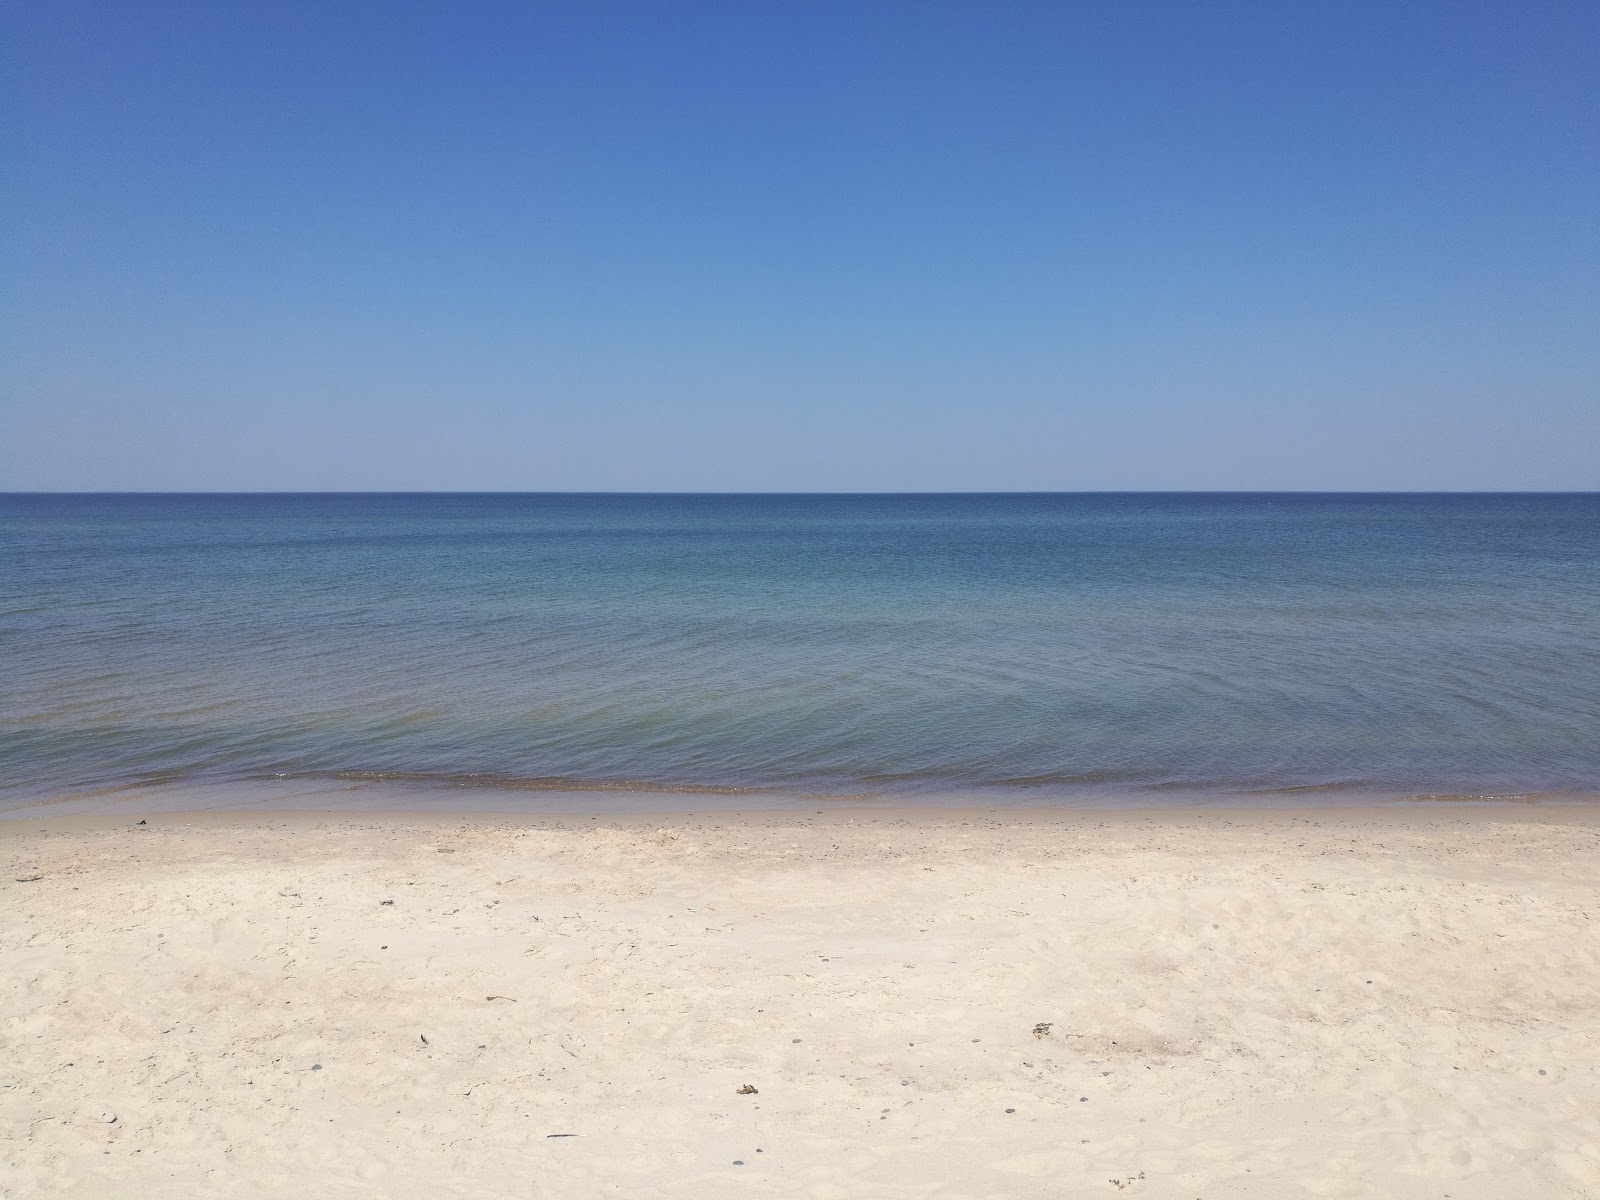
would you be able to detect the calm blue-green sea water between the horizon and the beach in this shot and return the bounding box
[0,494,1600,808]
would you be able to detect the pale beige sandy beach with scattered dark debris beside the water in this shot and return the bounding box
[0,806,1600,1200]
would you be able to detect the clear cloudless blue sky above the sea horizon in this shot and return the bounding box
[0,0,1600,491]
